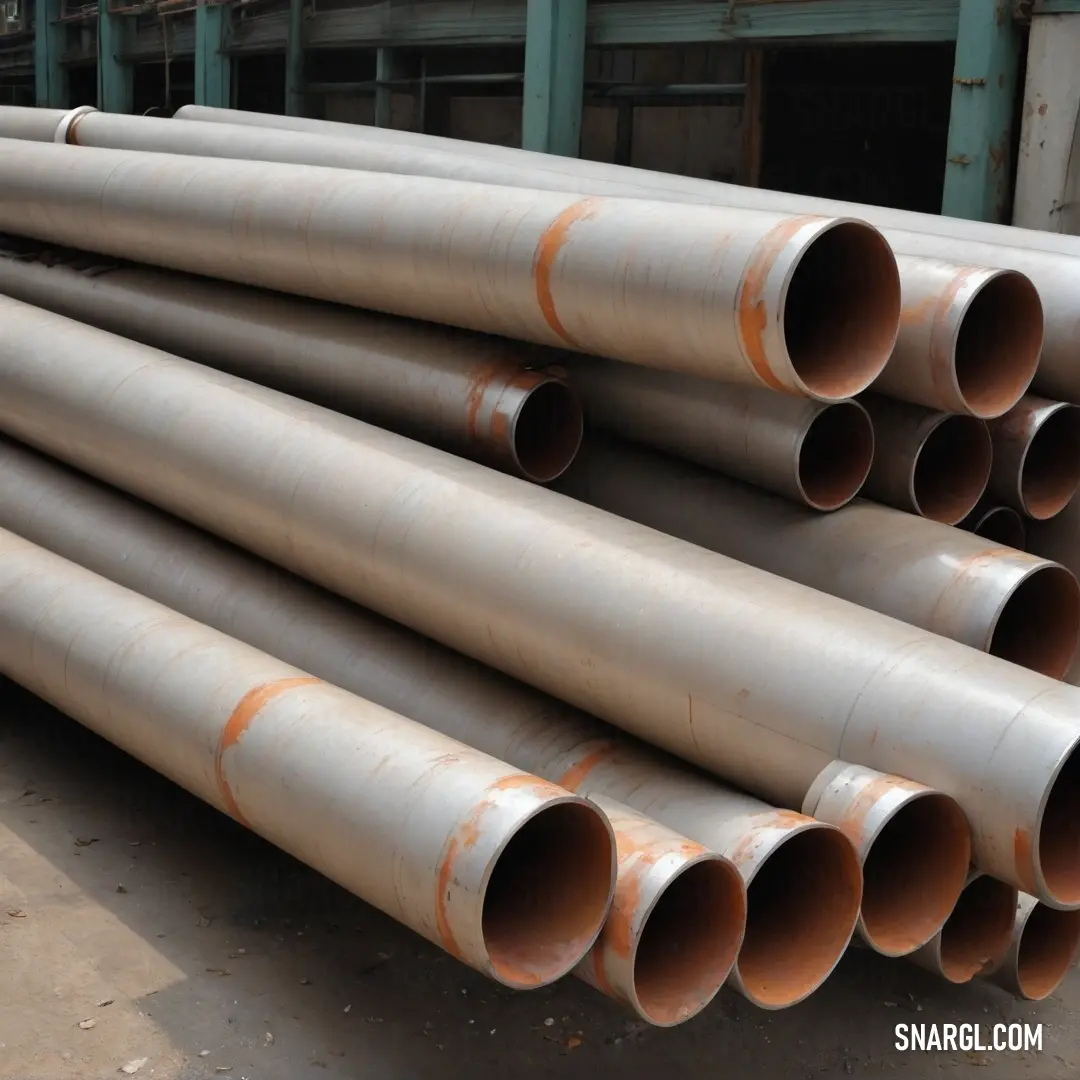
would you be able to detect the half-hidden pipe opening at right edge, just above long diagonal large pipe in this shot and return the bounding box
[987,565,1080,679]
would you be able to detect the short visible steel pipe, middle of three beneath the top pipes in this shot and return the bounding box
[862,394,994,525]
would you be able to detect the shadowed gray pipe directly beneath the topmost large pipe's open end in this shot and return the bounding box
[561,354,874,510]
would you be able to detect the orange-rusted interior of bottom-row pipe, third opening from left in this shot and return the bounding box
[739,828,862,1009]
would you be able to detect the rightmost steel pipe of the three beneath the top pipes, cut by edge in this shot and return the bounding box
[987,394,1080,521]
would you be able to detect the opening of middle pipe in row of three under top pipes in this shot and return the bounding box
[912,416,994,525]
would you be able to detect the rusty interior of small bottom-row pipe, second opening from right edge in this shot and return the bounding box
[941,874,1016,983]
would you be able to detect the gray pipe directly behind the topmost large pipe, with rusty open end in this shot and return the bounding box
[56,106,1043,417]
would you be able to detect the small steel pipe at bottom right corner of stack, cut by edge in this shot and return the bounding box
[986,892,1080,1001]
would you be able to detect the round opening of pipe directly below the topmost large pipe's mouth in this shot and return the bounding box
[798,402,874,510]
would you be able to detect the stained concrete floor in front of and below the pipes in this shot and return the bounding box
[0,683,1080,1080]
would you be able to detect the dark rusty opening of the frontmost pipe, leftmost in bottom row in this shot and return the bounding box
[483,802,615,987]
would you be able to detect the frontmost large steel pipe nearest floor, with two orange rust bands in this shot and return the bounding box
[0,522,615,987]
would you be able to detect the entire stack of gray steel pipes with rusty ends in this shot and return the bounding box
[0,103,1080,1026]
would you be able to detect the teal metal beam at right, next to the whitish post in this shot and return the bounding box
[942,0,1021,221]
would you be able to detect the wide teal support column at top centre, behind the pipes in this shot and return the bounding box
[522,0,585,158]
